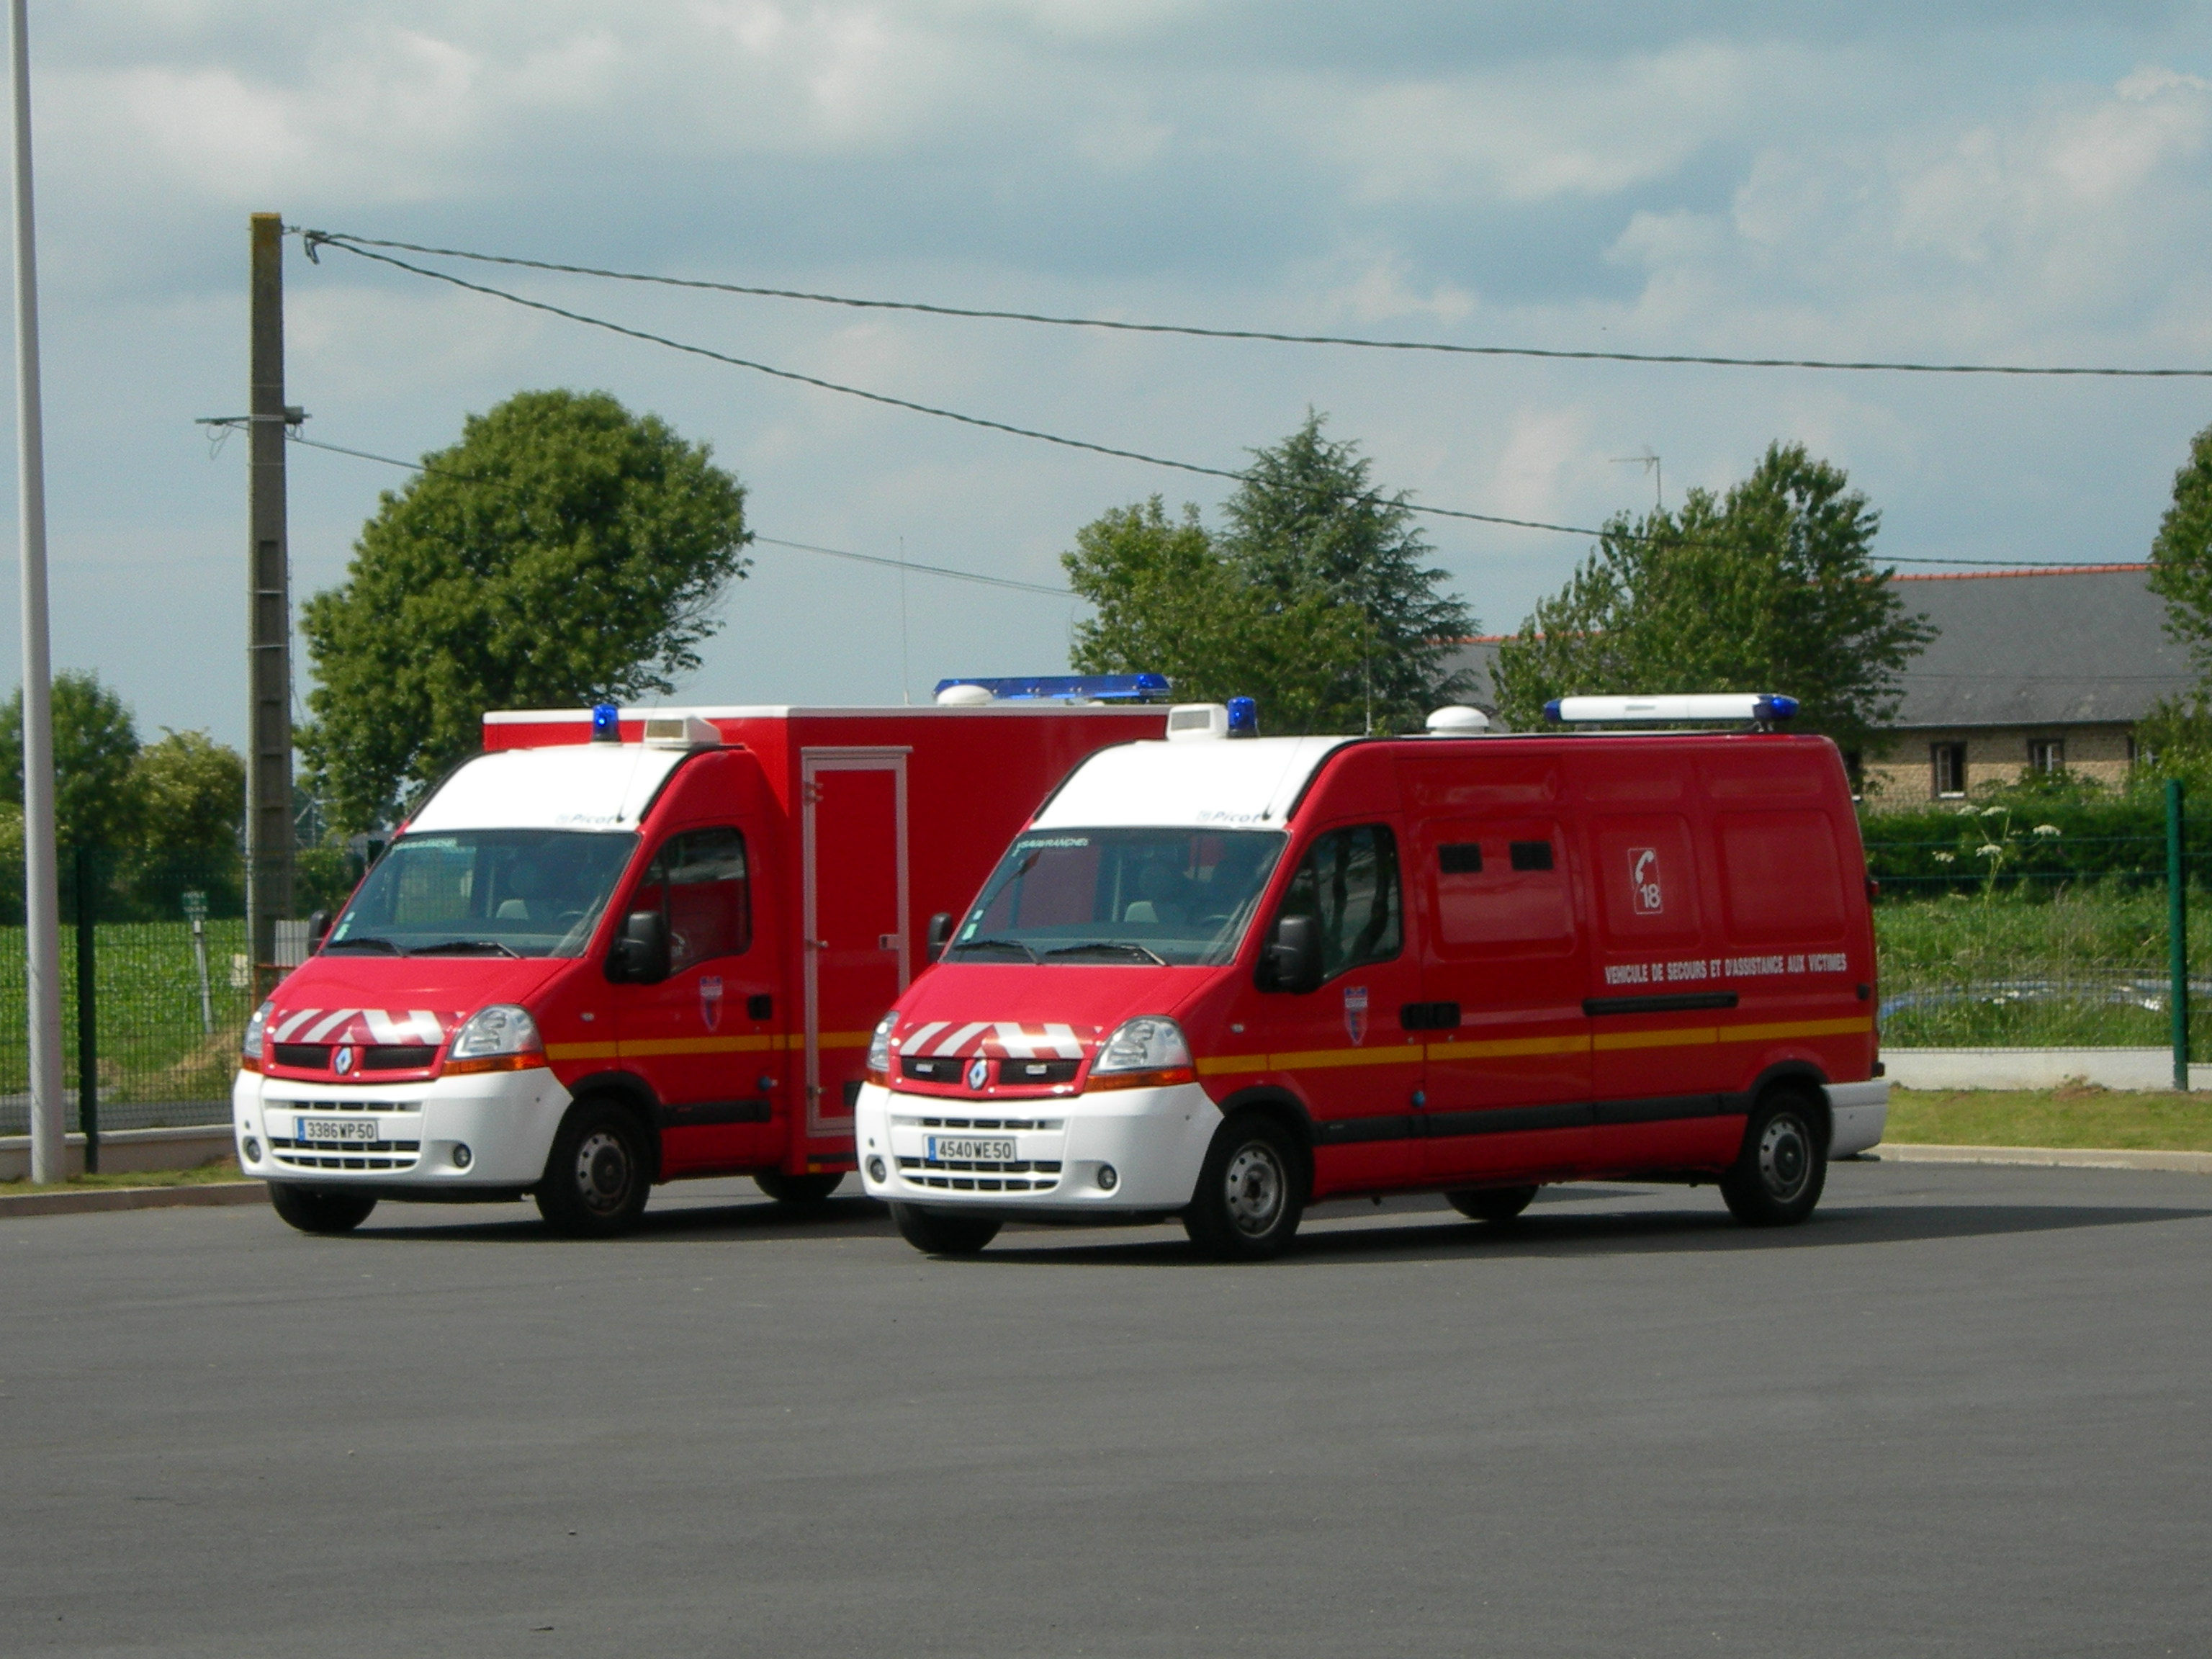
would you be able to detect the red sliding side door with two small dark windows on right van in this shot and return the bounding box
[1416,814,1593,1184]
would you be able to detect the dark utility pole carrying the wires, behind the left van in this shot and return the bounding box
[246,217,299,1000]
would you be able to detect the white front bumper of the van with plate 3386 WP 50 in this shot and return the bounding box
[230,1066,569,1188]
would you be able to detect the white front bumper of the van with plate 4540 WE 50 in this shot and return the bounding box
[854,1084,1221,1215]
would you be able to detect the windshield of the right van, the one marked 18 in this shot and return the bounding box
[947,830,1283,966]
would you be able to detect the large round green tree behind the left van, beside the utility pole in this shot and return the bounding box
[299,392,750,830]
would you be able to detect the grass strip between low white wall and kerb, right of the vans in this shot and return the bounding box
[1884,1084,2212,1153]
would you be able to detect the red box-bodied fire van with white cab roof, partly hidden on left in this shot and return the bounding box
[233,675,1166,1234]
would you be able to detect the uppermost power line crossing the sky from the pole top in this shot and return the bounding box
[301,230,2212,380]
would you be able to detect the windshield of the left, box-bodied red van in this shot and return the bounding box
[323,830,637,956]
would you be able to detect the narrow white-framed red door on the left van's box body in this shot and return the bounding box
[799,747,909,1150]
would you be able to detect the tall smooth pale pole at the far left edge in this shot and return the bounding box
[9,0,68,1181]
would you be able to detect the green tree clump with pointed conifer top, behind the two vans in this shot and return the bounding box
[1062,416,1473,732]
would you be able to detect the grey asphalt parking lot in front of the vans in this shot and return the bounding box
[0,1164,2212,1659]
